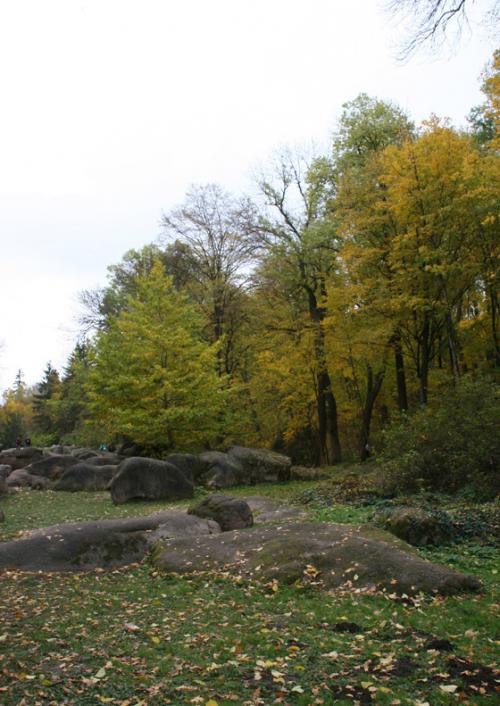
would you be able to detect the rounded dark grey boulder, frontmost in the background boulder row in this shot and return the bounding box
[109,456,194,504]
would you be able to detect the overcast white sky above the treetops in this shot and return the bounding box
[0,0,495,389]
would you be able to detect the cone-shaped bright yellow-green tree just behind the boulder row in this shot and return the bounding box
[88,261,227,451]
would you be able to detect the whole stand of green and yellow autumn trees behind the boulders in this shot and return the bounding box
[0,52,500,496]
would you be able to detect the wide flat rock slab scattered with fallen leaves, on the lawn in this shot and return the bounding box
[153,522,481,595]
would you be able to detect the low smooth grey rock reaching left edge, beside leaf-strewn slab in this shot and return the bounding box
[0,510,220,571]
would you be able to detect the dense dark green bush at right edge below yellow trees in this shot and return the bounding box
[377,378,500,499]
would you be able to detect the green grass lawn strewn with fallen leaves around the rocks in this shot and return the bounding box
[0,483,500,706]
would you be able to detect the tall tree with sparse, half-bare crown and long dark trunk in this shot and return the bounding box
[255,150,342,464]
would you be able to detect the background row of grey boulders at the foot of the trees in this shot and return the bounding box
[0,446,314,516]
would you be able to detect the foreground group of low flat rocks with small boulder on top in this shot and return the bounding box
[0,494,481,595]
